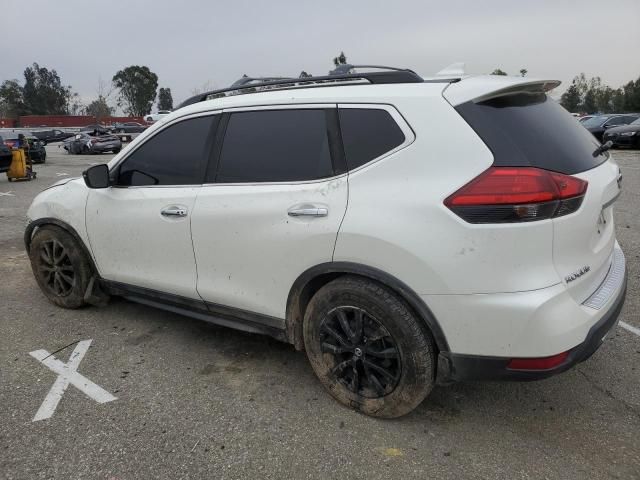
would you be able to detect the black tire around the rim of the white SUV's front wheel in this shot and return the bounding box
[29,225,93,308]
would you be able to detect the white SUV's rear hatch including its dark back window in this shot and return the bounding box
[445,80,621,303]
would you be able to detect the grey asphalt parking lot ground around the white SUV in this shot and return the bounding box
[0,144,640,480]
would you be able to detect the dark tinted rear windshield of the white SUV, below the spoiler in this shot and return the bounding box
[456,93,608,175]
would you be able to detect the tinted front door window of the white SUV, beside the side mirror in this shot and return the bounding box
[118,115,219,186]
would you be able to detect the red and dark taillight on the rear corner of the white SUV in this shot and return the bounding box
[444,167,587,223]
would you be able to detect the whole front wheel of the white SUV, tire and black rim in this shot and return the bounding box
[29,225,93,308]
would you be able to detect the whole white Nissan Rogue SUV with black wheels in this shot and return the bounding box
[25,66,626,417]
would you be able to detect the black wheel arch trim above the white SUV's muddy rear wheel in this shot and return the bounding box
[286,262,449,352]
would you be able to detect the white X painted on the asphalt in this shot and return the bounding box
[29,339,117,422]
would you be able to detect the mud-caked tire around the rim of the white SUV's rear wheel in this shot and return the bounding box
[303,277,435,418]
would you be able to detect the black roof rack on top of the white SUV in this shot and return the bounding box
[178,64,452,108]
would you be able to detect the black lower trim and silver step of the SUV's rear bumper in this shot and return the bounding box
[438,247,627,383]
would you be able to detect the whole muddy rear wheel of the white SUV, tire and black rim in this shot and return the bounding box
[303,276,435,418]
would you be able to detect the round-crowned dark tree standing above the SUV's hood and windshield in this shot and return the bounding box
[112,65,158,116]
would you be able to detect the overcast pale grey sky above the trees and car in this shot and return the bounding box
[0,0,640,111]
